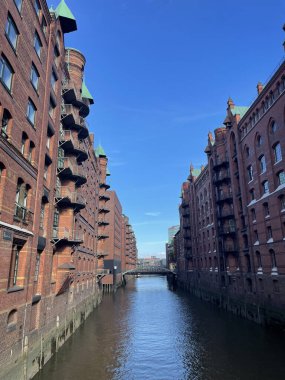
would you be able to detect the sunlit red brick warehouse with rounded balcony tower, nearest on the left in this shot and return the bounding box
[0,0,136,379]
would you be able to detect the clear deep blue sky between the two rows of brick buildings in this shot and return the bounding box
[49,0,285,257]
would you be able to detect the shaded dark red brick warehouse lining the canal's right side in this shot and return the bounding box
[177,44,285,324]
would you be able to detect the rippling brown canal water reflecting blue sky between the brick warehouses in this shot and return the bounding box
[35,276,285,380]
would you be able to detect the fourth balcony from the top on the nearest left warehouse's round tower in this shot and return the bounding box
[57,157,87,186]
